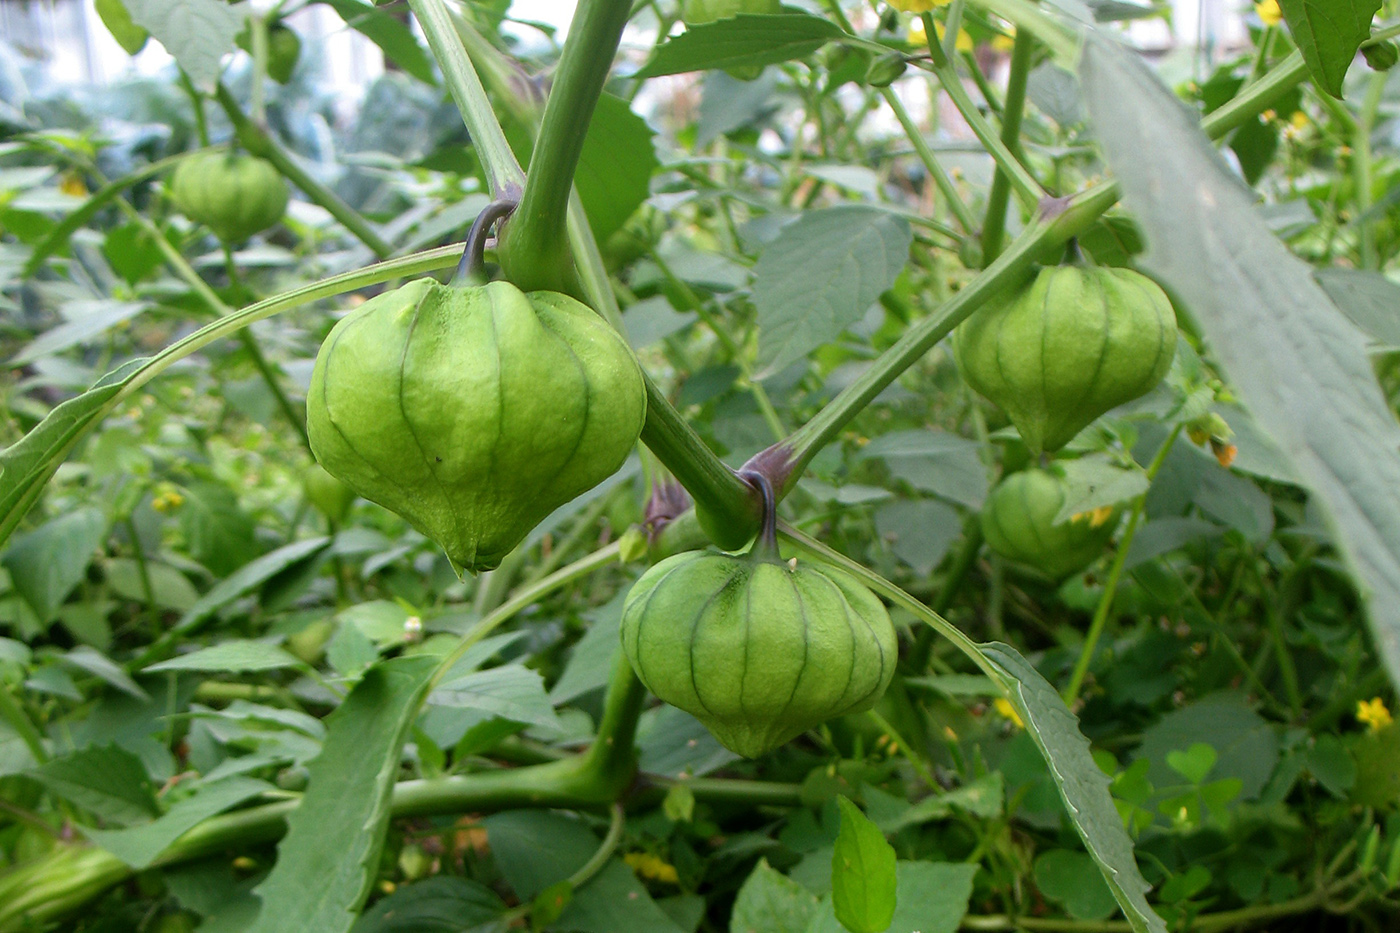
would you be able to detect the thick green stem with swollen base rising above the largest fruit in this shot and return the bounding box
[497,0,631,294]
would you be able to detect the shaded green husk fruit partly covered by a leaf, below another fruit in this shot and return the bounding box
[981,469,1119,580]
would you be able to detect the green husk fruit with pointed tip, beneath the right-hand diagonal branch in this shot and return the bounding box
[953,266,1176,452]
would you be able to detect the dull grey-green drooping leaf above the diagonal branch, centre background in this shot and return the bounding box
[741,205,914,378]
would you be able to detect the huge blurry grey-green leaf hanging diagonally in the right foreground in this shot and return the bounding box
[1082,38,1400,684]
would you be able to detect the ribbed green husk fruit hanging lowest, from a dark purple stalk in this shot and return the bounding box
[622,546,897,758]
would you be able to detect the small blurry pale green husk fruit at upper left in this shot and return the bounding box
[169,153,288,242]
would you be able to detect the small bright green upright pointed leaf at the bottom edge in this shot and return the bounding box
[832,797,896,933]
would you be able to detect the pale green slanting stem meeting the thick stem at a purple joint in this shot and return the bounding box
[409,0,525,195]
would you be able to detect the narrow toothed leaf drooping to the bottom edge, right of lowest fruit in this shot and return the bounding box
[979,643,1166,933]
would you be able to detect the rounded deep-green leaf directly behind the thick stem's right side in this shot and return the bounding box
[574,94,661,242]
